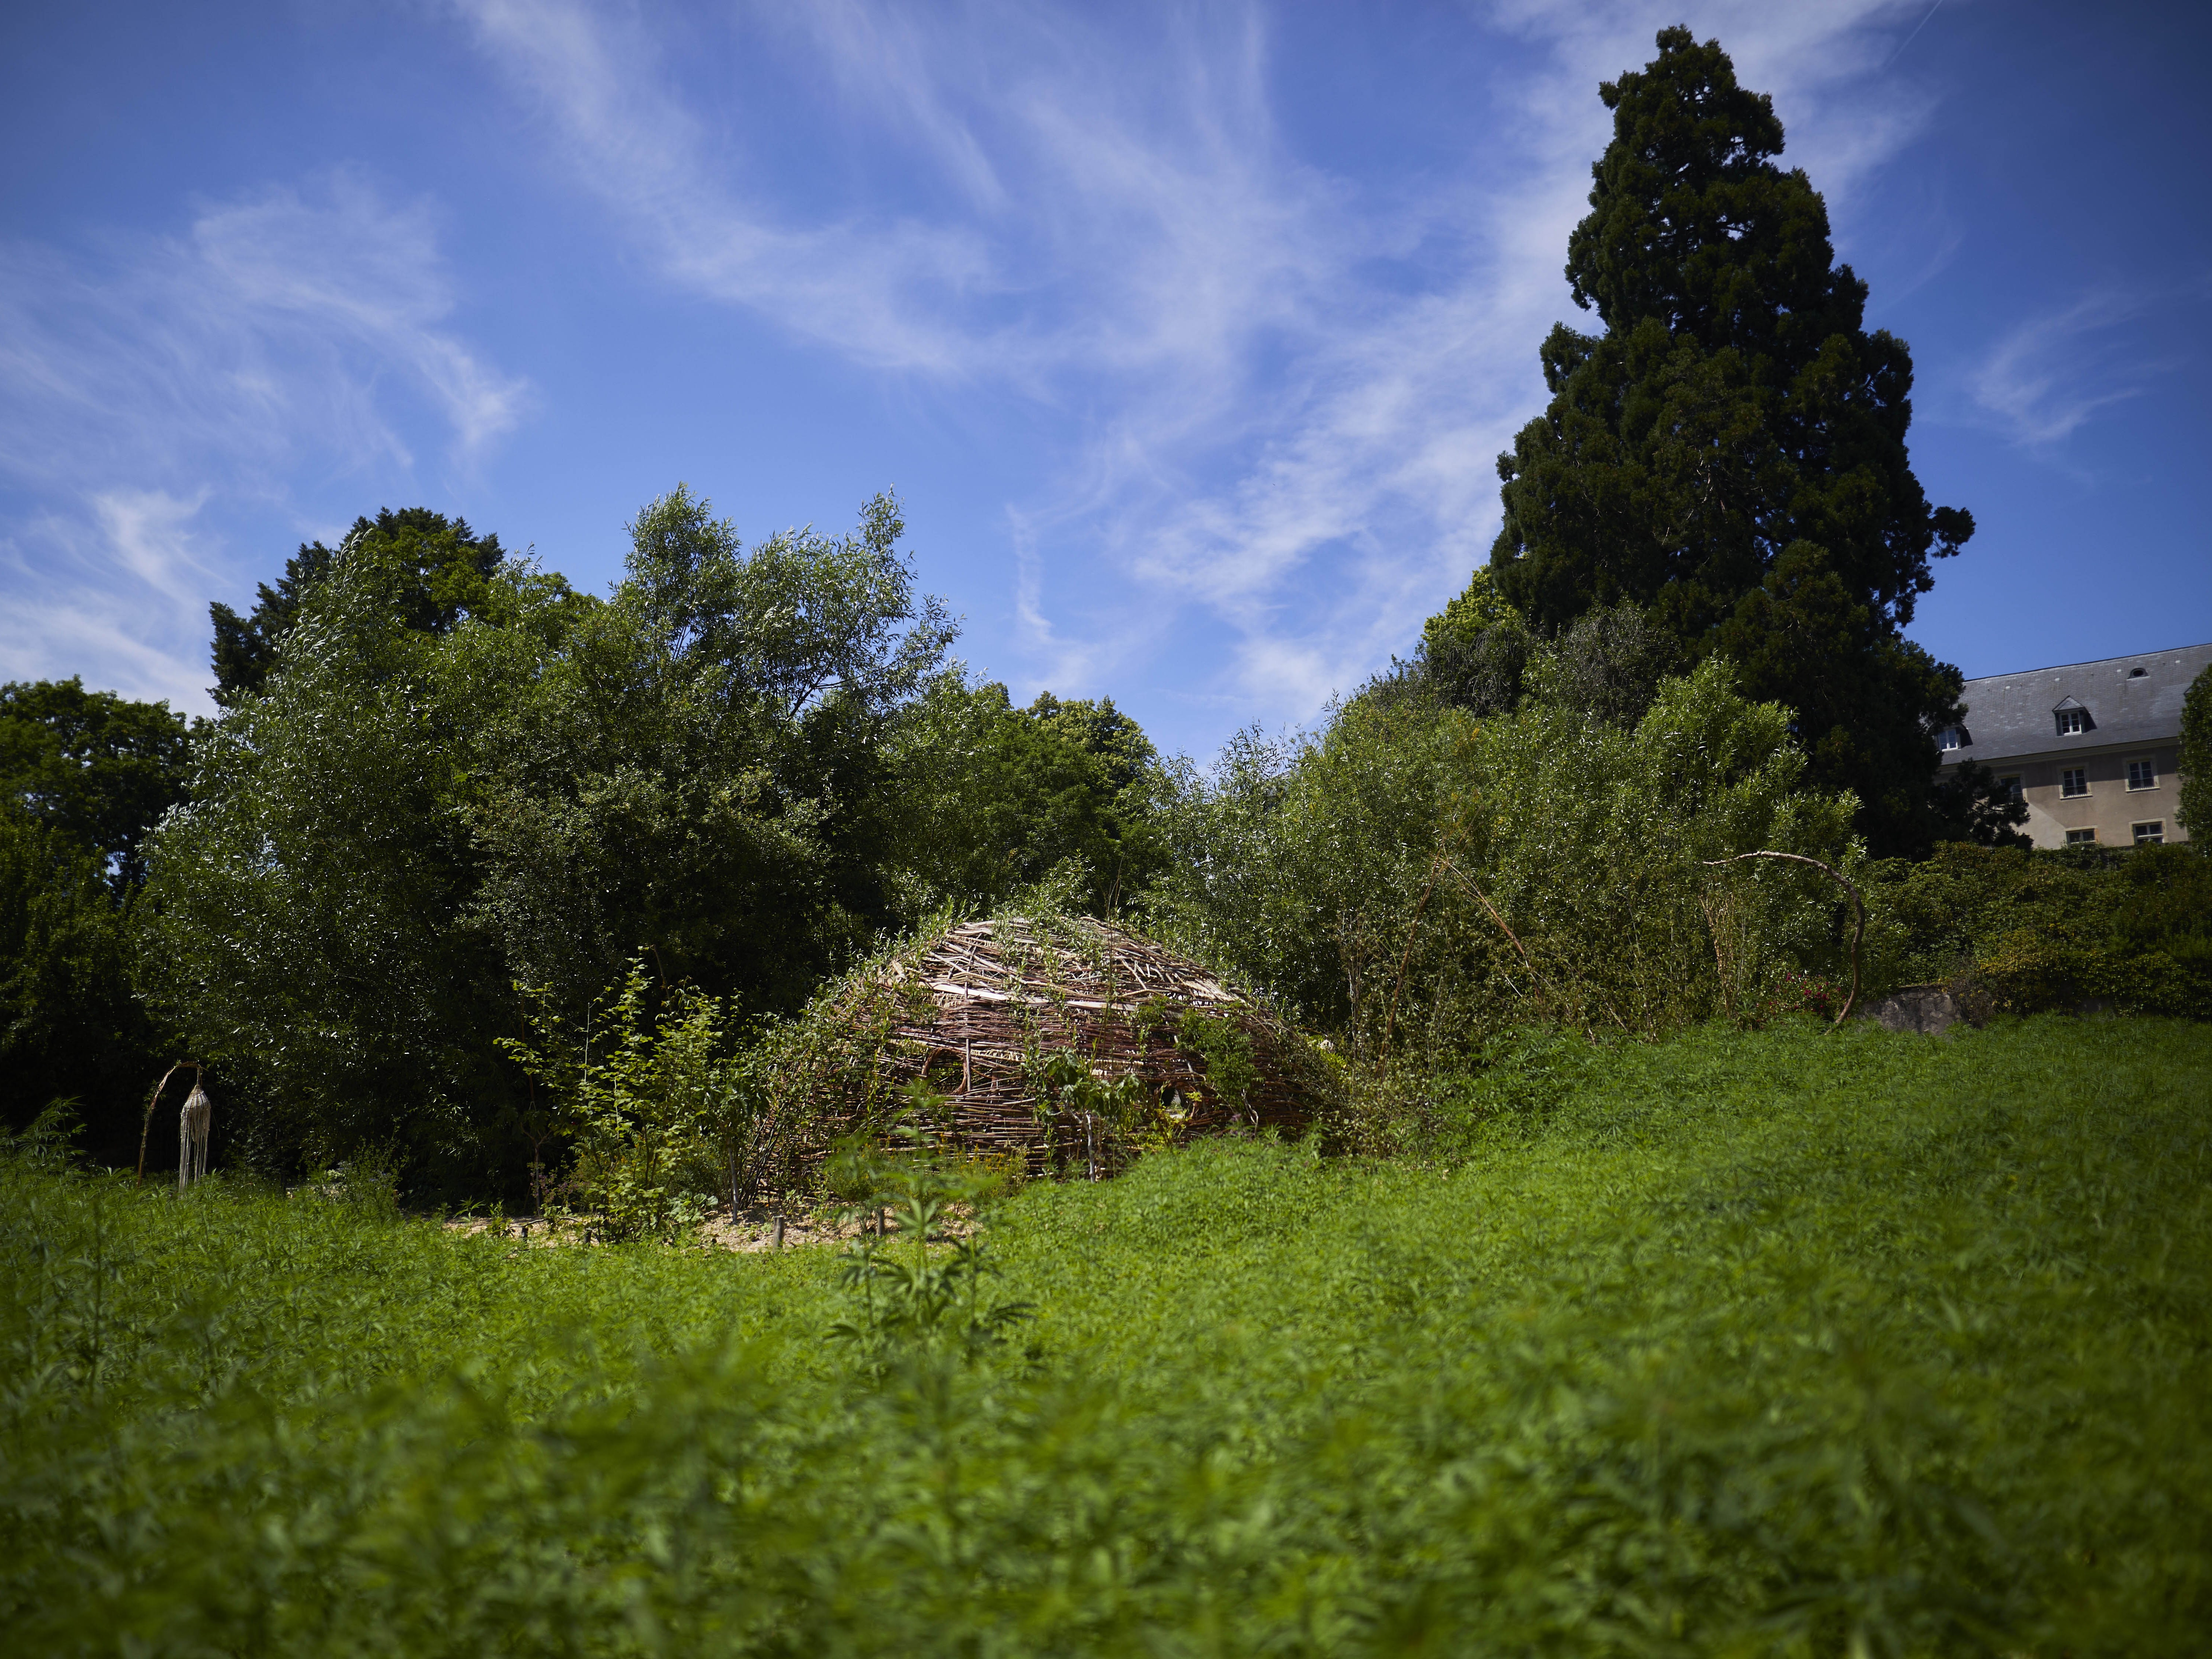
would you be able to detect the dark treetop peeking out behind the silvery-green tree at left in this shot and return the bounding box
[208,507,507,708]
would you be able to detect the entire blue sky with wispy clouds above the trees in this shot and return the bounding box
[0,0,2212,757]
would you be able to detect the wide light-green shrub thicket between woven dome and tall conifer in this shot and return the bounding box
[1152,655,1858,1057]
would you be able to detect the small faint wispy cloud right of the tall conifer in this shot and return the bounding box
[1966,290,2159,447]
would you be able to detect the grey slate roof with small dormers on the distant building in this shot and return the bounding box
[1944,644,2212,763]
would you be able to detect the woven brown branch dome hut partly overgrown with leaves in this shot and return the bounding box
[827,916,1334,1172]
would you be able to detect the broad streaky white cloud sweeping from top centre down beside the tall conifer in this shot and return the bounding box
[460,0,1926,734]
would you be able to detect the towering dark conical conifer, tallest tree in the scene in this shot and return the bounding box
[1491,29,1973,852]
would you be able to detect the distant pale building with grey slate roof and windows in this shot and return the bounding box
[1940,644,2212,847]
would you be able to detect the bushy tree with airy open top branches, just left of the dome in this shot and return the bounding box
[453,489,953,1013]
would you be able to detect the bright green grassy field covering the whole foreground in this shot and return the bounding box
[0,1018,2212,1655]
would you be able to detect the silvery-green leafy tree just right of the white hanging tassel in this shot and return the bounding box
[141,540,527,1190]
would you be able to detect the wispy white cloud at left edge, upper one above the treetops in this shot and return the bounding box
[0,175,529,484]
